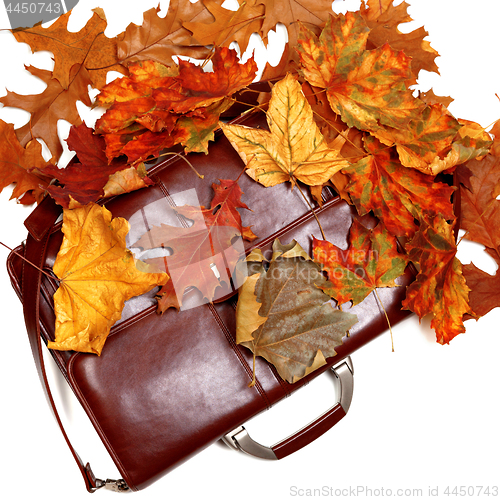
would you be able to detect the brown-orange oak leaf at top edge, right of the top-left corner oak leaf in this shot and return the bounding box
[117,0,211,66]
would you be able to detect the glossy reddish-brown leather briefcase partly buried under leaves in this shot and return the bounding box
[8,108,414,491]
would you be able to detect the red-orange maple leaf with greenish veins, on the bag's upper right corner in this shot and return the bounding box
[343,136,455,237]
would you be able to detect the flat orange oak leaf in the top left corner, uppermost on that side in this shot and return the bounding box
[13,8,127,90]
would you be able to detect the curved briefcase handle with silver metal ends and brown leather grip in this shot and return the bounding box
[222,356,354,460]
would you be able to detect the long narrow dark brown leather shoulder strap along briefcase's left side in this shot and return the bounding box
[22,197,97,493]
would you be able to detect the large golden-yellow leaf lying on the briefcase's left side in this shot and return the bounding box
[48,204,169,355]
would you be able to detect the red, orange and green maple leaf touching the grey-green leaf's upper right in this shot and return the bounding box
[313,219,408,305]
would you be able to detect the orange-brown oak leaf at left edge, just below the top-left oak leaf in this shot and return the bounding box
[0,64,92,160]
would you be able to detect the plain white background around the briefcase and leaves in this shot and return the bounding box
[0,0,500,500]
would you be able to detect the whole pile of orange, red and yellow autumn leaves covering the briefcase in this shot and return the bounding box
[0,0,500,382]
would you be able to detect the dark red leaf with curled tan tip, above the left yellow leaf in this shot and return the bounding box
[40,124,153,208]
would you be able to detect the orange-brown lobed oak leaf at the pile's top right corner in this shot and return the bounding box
[360,0,439,83]
